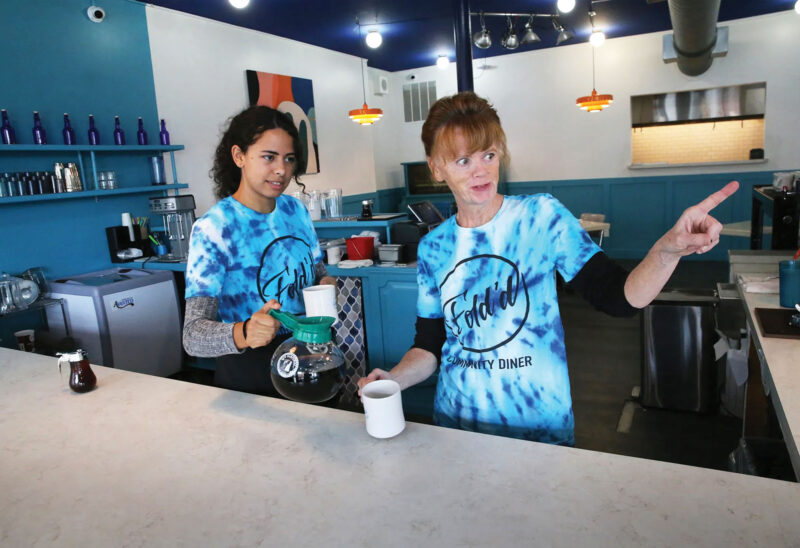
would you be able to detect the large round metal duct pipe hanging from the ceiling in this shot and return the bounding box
[669,0,720,76]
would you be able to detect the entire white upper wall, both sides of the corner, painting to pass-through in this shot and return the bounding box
[147,6,800,214]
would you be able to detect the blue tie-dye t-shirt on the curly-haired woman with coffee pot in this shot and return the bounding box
[186,195,322,323]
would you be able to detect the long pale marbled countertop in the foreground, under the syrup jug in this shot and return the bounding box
[0,349,800,547]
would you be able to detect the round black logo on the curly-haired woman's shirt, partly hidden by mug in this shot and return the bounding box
[257,236,314,304]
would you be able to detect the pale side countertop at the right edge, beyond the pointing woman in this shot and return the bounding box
[739,286,800,478]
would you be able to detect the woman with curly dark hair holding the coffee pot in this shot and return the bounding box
[183,106,336,396]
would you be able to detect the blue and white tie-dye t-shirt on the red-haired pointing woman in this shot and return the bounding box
[417,194,600,444]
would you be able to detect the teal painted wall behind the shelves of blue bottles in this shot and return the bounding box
[0,0,162,277]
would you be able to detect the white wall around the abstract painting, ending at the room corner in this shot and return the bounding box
[147,5,375,215]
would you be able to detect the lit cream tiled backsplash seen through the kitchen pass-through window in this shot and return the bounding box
[631,119,764,164]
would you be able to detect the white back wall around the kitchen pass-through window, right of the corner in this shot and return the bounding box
[375,10,800,188]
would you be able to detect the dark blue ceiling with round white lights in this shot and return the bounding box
[142,0,800,72]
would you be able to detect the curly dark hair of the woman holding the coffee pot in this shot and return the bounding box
[209,105,306,200]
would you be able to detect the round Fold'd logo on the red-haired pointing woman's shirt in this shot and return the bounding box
[439,255,530,352]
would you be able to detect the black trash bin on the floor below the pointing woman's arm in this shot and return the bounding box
[640,289,719,413]
